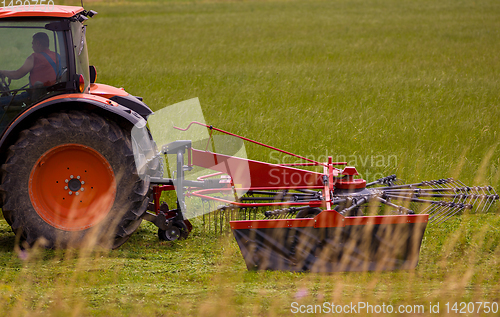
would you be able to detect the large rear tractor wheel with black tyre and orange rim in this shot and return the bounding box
[1,111,149,248]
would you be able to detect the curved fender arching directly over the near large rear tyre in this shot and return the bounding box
[0,94,146,164]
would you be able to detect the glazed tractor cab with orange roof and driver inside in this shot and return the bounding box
[0,6,95,135]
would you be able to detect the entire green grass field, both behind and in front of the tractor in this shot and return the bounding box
[0,0,500,316]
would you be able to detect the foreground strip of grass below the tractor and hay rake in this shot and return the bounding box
[0,214,500,316]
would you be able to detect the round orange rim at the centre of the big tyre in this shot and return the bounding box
[28,144,116,231]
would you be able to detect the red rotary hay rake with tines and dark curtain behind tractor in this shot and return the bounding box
[147,122,499,272]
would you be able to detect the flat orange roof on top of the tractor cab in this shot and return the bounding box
[0,5,84,19]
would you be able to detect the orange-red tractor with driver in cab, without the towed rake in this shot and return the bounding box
[0,5,172,247]
